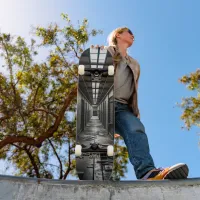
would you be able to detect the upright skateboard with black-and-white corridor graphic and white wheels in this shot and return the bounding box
[75,47,115,180]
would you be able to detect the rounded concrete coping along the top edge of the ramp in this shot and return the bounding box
[0,175,200,188]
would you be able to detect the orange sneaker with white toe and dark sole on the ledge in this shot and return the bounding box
[142,163,189,180]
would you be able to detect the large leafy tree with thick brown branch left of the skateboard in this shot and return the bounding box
[0,14,126,179]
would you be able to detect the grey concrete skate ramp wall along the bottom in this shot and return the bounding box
[0,176,200,200]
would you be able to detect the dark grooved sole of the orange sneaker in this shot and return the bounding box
[163,163,189,179]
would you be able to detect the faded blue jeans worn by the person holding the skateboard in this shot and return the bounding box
[115,101,155,179]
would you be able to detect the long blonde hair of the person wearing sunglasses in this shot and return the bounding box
[107,27,129,71]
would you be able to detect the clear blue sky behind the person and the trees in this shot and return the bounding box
[0,0,200,180]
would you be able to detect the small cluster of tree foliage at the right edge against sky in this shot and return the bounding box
[178,69,200,130]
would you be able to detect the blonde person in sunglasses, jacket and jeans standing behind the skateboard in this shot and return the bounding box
[104,27,189,180]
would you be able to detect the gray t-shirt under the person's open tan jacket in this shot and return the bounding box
[114,58,134,104]
